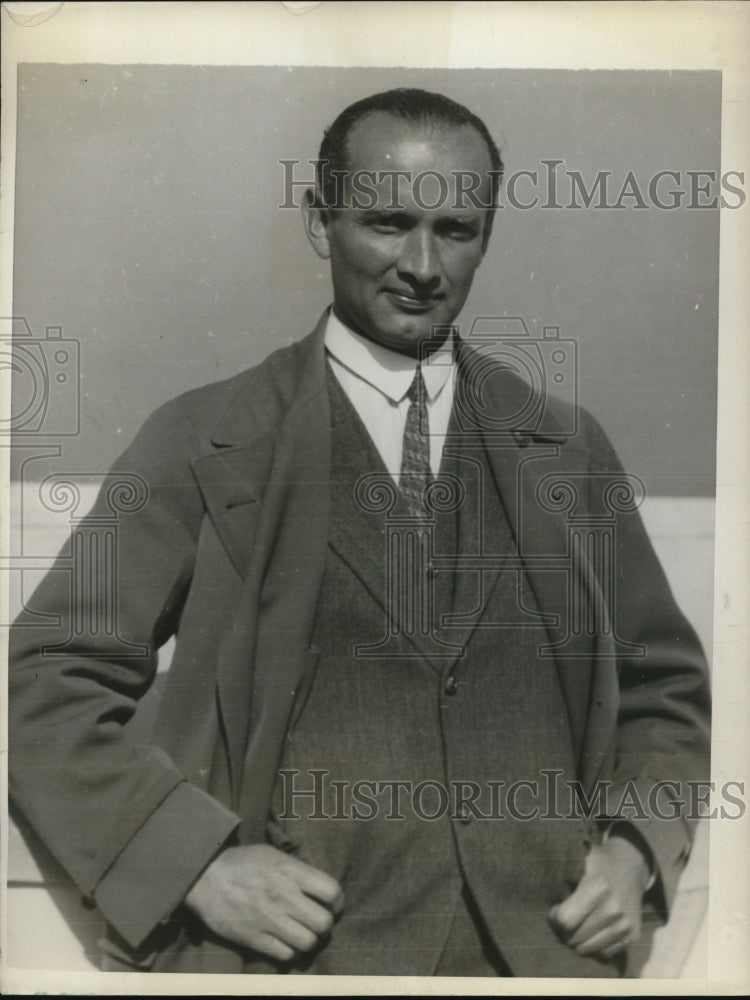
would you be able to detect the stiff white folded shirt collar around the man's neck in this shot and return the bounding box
[325,309,454,403]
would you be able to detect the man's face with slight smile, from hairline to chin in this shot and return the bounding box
[308,112,491,354]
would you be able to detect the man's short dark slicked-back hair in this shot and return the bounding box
[315,87,503,222]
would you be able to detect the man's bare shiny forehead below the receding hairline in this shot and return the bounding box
[347,111,492,179]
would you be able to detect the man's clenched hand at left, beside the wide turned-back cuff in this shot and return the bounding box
[185,844,343,962]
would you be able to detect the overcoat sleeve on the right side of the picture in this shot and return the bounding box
[583,404,711,909]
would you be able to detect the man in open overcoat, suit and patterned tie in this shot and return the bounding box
[11,90,708,976]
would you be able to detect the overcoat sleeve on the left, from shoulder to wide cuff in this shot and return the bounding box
[9,399,239,947]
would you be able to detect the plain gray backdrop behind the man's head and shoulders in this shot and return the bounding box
[8,64,720,496]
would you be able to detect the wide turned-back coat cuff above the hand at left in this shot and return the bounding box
[93,782,240,949]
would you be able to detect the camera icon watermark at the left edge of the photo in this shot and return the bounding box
[0,316,81,437]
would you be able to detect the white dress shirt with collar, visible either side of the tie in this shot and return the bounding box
[325,309,456,485]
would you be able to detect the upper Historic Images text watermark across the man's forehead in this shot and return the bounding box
[278,159,747,212]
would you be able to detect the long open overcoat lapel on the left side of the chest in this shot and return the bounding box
[193,319,330,816]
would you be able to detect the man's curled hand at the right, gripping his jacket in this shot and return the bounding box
[549,835,649,959]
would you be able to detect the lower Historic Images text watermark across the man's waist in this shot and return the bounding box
[278,768,747,822]
